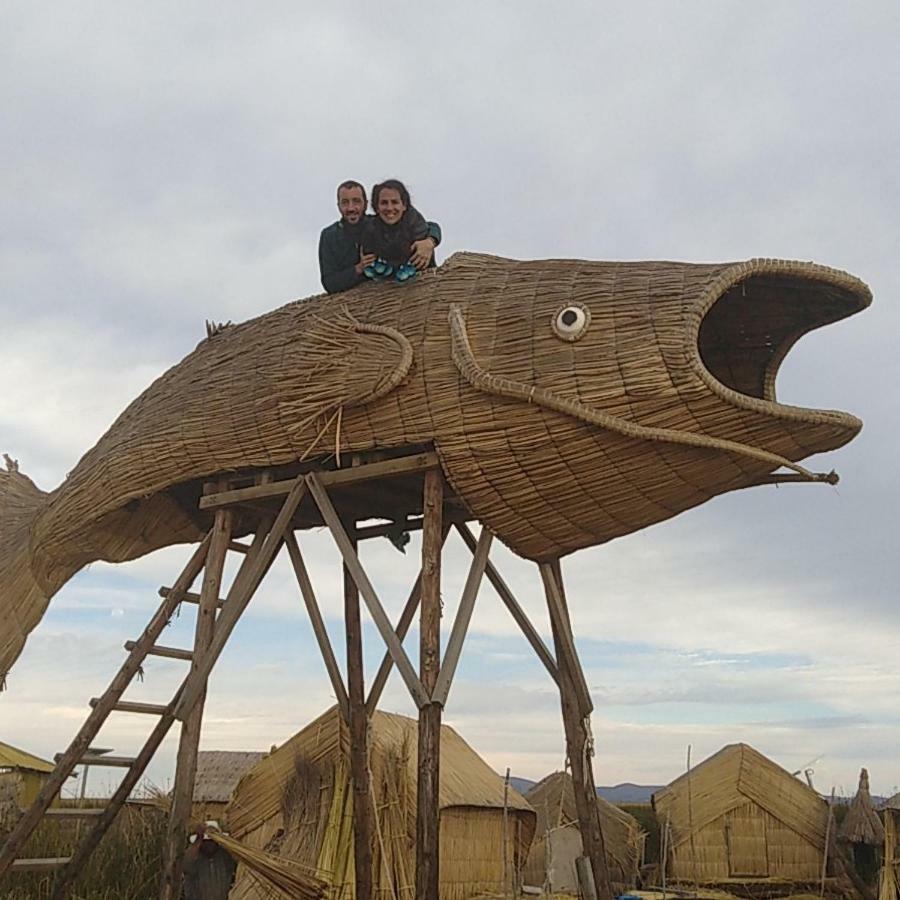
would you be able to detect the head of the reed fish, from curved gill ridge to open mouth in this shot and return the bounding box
[444,253,871,558]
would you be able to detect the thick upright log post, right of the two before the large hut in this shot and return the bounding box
[416,469,444,900]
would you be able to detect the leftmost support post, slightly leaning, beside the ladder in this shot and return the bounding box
[159,500,234,900]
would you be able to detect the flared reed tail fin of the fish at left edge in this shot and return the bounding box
[0,454,50,690]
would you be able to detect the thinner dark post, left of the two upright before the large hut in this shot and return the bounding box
[344,523,372,900]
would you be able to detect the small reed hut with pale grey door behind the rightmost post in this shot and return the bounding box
[523,772,645,894]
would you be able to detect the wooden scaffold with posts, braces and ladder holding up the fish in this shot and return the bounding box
[0,447,611,900]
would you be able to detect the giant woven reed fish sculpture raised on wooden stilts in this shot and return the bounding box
[0,253,871,673]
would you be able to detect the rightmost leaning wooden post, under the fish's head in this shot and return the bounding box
[540,561,613,900]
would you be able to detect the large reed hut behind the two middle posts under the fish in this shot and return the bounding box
[227,707,536,900]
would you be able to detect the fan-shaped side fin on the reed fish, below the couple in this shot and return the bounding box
[278,307,413,446]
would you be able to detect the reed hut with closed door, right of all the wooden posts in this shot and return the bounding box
[652,744,831,885]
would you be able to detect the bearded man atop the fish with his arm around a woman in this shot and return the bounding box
[319,181,441,294]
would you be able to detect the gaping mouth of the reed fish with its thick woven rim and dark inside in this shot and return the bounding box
[688,259,872,422]
